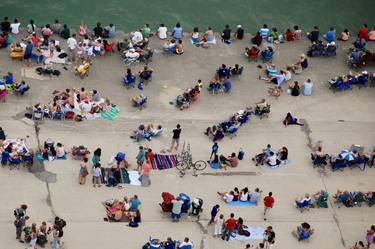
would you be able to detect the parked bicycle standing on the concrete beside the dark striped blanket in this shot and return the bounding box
[176,143,207,177]
